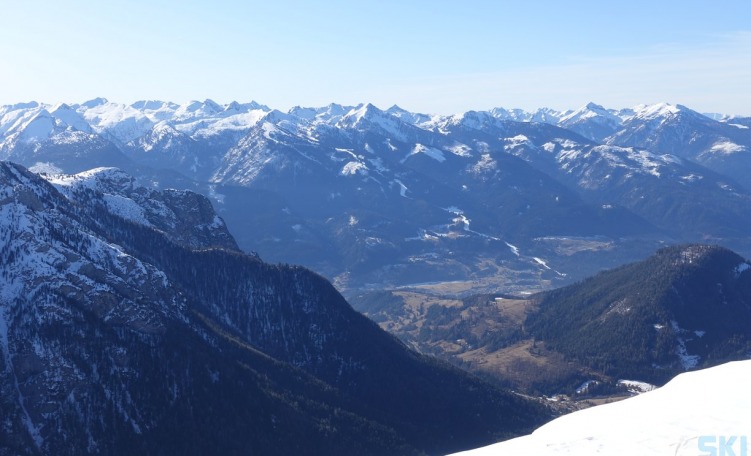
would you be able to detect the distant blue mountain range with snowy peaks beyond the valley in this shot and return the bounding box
[0,99,751,287]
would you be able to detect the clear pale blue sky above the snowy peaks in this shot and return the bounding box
[0,0,751,115]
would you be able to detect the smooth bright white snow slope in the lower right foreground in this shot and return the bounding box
[452,361,751,456]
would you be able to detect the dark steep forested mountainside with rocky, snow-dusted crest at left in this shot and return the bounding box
[0,163,545,454]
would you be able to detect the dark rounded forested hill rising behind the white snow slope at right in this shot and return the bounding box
[525,245,751,383]
